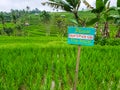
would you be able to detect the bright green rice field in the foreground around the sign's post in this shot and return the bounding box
[0,37,120,90]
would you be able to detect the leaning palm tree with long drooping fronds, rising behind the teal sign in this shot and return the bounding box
[42,0,84,26]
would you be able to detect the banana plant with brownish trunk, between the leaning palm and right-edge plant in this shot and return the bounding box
[84,0,113,37]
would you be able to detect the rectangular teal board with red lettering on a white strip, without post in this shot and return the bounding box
[68,27,95,46]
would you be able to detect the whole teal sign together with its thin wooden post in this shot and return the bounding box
[68,27,95,90]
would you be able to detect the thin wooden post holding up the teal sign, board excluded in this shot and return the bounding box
[73,46,81,90]
